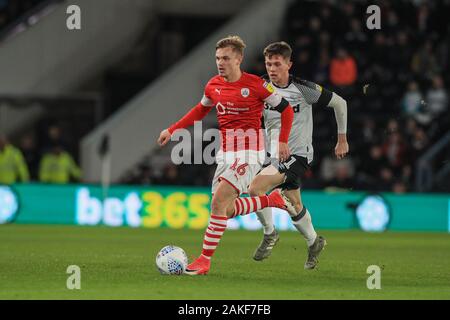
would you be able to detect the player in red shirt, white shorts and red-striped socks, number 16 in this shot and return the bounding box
[158,36,294,275]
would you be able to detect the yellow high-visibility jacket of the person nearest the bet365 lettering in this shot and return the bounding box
[39,144,81,184]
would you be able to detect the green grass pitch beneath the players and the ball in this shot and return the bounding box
[0,224,450,300]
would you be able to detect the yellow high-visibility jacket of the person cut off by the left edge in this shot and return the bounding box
[0,134,30,184]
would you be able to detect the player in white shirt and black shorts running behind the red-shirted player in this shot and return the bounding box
[249,42,349,269]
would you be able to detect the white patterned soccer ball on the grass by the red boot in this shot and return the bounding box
[156,245,188,275]
